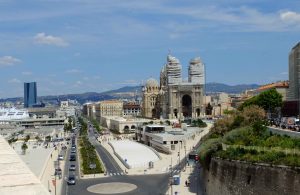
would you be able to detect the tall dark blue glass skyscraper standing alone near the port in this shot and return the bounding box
[24,82,37,108]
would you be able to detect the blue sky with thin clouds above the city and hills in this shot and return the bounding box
[0,0,300,98]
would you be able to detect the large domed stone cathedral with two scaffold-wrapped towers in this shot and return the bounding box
[142,55,205,119]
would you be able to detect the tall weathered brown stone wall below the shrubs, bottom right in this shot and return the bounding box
[203,158,300,195]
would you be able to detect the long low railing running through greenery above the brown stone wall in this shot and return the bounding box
[222,143,300,155]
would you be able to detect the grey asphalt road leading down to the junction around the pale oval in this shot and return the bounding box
[62,119,198,195]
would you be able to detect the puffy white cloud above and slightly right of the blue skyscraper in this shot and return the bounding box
[34,32,69,47]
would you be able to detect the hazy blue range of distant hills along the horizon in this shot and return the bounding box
[0,83,259,104]
